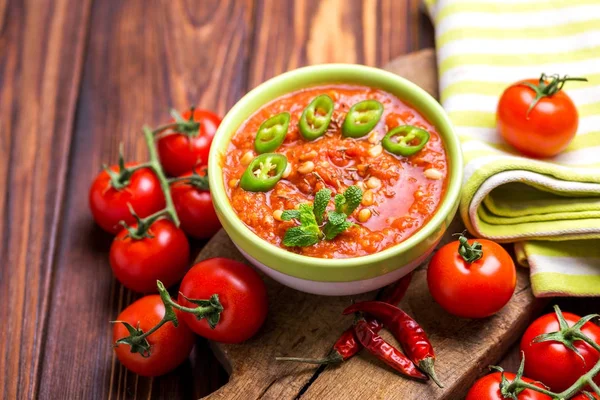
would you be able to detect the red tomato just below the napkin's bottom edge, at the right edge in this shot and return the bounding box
[521,312,600,392]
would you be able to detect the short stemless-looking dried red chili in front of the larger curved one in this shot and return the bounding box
[354,318,429,381]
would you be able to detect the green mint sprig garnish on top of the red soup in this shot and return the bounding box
[281,186,363,247]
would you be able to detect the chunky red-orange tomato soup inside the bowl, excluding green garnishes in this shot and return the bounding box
[223,85,448,258]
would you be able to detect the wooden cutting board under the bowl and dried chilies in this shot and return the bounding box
[198,50,542,400]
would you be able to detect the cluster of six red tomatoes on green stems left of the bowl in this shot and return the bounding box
[89,110,268,376]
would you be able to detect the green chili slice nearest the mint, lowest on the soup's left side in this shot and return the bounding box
[240,153,287,192]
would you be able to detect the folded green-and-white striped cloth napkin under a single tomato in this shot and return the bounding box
[426,0,600,297]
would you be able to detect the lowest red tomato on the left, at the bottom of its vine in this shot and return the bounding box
[113,294,195,376]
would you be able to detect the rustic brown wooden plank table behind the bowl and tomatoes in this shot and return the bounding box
[0,0,597,399]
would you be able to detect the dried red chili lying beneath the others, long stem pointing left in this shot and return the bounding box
[276,272,412,364]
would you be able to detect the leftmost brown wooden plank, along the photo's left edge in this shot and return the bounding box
[0,0,90,399]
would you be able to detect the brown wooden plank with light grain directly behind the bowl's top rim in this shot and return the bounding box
[248,0,433,87]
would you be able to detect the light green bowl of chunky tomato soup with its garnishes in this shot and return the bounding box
[209,64,462,295]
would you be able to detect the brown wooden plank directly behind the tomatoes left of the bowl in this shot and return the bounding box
[33,0,252,399]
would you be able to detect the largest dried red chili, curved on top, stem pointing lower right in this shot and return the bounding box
[344,301,443,387]
